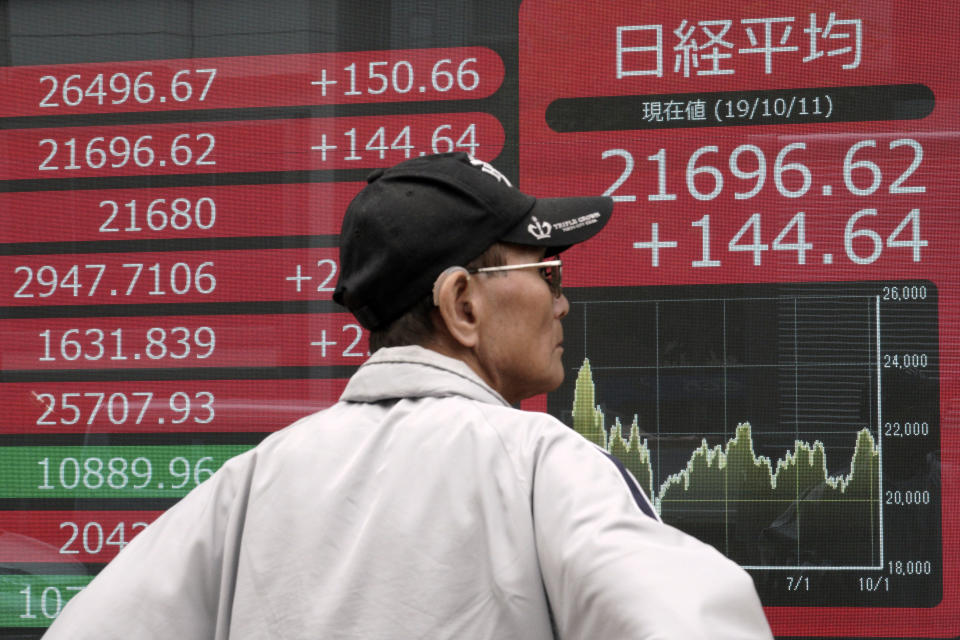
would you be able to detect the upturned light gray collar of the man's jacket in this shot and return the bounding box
[340,346,510,406]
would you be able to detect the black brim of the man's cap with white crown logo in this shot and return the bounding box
[501,196,613,253]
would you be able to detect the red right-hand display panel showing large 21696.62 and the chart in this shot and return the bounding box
[519,0,960,638]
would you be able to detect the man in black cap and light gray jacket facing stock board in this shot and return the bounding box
[49,153,770,640]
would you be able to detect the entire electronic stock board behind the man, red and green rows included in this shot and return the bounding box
[0,0,960,638]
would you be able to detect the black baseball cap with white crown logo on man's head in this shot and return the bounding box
[333,152,613,330]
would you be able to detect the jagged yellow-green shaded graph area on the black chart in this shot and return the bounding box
[573,359,880,568]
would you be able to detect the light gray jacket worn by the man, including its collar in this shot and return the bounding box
[45,347,771,640]
